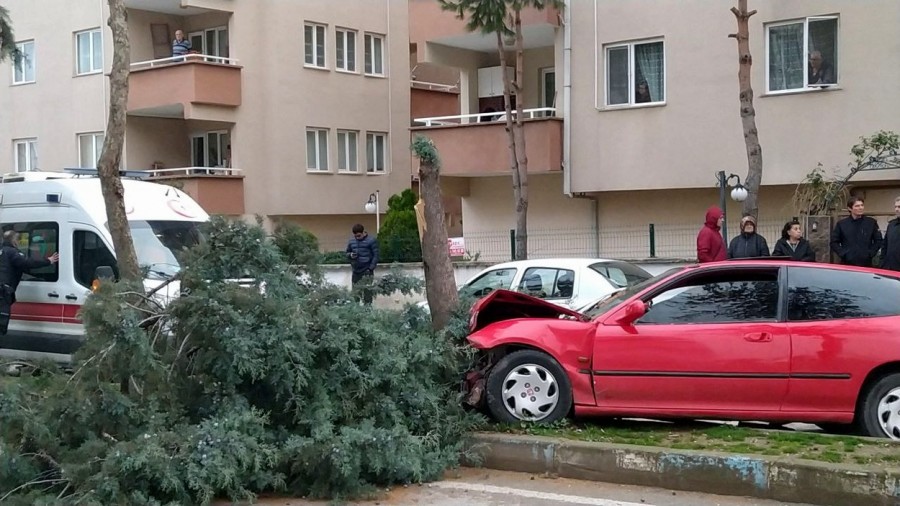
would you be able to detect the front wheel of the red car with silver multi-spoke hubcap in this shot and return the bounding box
[486,350,572,423]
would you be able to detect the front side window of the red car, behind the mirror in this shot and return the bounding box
[638,267,779,324]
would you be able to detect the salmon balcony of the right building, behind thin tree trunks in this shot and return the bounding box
[410,107,563,177]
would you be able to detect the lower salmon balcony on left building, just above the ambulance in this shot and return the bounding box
[148,167,244,216]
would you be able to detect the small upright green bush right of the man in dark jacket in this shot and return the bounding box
[378,189,422,263]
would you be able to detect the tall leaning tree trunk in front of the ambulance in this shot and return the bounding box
[97,0,142,280]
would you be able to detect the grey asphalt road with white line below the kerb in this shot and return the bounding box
[248,468,812,506]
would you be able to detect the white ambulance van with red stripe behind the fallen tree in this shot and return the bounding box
[0,169,209,362]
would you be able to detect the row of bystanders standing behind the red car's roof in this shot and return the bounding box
[697,197,900,271]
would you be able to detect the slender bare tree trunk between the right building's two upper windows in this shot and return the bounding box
[729,0,762,217]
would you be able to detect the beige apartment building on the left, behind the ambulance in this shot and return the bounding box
[0,0,411,245]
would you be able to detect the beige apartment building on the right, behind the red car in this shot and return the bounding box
[410,0,900,258]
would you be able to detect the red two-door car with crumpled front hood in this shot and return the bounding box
[466,259,900,439]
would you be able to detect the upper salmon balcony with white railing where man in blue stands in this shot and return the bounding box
[128,54,241,122]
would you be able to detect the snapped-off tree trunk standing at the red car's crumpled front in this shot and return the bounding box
[413,136,459,330]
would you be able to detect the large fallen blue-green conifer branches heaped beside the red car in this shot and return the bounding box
[0,218,476,505]
